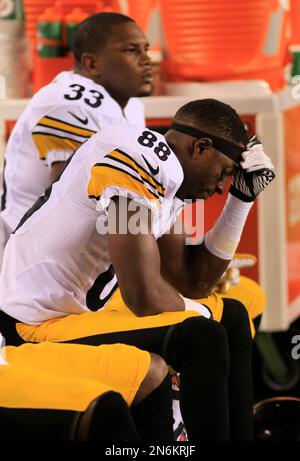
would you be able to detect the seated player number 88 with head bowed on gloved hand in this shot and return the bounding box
[1,100,275,441]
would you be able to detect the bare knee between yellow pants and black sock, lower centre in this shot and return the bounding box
[134,354,169,404]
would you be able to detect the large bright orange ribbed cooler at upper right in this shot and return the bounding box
[160,0,290,91]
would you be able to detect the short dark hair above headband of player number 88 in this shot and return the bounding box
[173,99,249,145]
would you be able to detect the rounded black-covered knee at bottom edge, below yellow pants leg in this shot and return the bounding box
[74,391,140,442]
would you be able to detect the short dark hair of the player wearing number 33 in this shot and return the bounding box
[72,13,135,66]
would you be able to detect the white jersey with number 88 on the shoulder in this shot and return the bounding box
[0,125,183,325]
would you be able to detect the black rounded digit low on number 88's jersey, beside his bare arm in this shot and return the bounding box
[86,265,118,311]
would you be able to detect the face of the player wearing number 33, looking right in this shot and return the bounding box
[99,22,153,106]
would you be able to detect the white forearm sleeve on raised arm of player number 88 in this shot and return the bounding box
[204,194,254,260]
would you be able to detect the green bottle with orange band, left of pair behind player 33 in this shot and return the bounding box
[37,21,65,58]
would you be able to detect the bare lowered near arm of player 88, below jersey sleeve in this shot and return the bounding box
[108,197,184,316]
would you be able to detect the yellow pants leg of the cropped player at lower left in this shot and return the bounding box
[6,342,151,404]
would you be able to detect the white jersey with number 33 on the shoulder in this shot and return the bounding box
[1,72,145,231]
